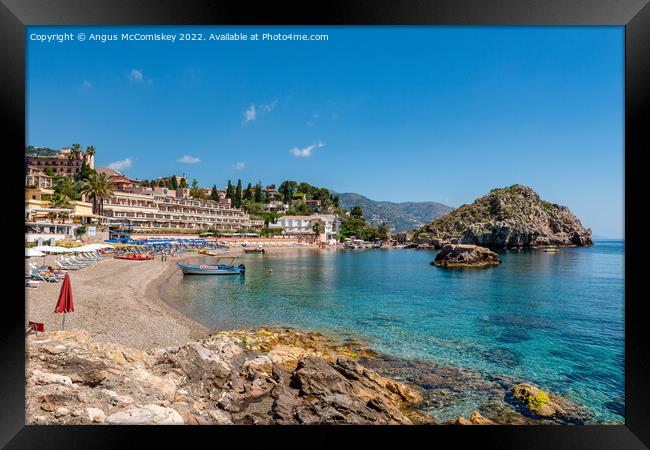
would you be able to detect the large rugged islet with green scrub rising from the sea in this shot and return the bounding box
[416,184,592,248]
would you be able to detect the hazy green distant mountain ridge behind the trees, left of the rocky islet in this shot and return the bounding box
[336,192,454,231]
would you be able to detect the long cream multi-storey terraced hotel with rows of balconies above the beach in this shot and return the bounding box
[103,186,264,232]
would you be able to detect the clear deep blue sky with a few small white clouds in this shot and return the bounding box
[26,26,624,237]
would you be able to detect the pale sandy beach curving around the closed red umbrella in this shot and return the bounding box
[25,253,208,350]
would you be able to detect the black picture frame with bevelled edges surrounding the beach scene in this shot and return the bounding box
[0,0,650,449]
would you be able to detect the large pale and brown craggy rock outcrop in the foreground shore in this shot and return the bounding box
[26,328,427,424]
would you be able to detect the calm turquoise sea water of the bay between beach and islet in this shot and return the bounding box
[162,241,624,422]
